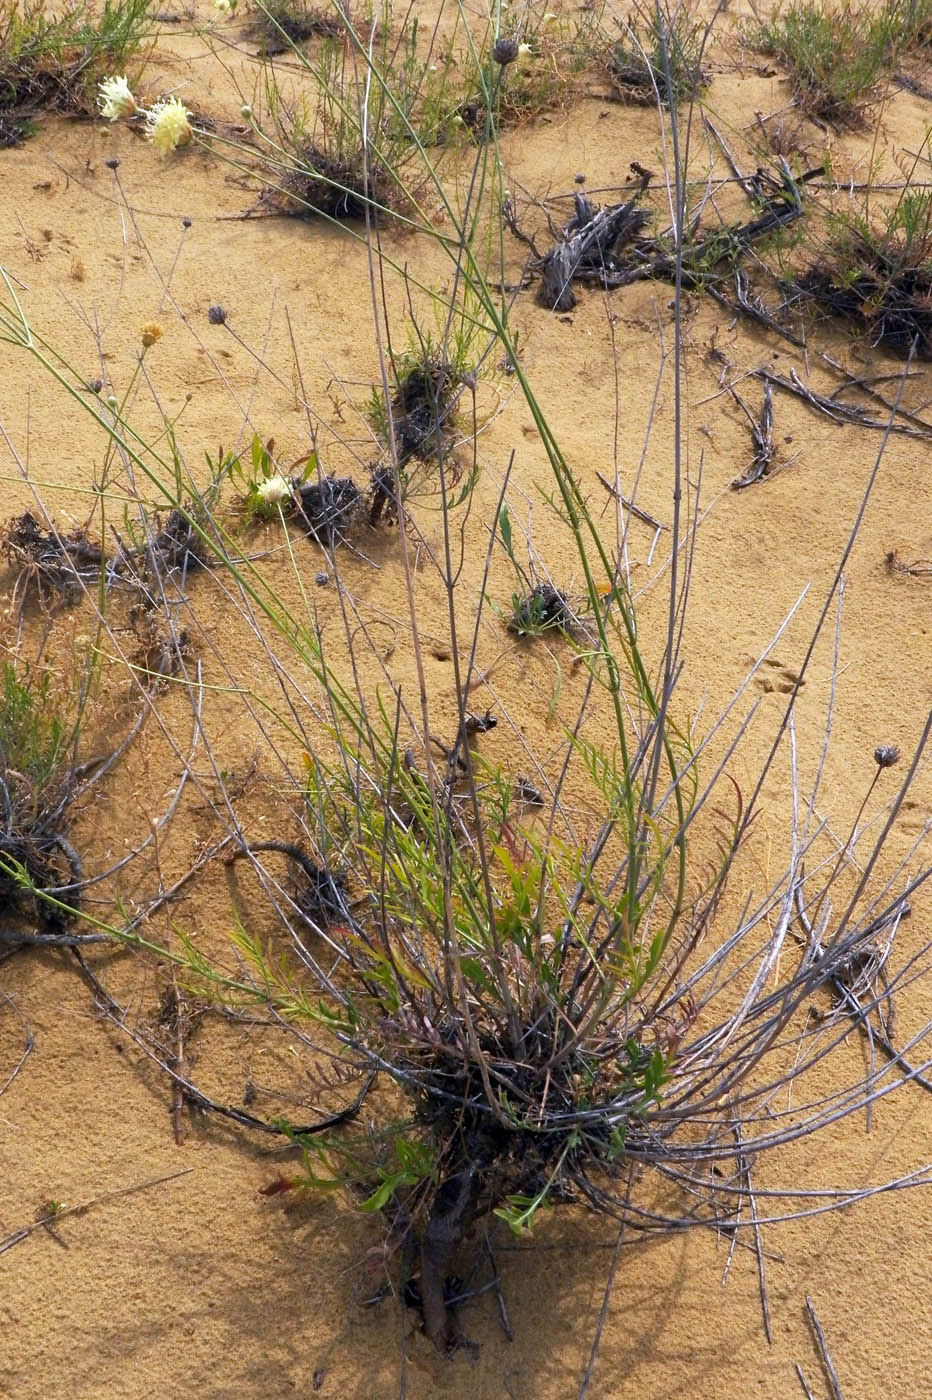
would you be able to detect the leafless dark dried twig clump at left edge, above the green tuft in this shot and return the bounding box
[0,511,106,609]
